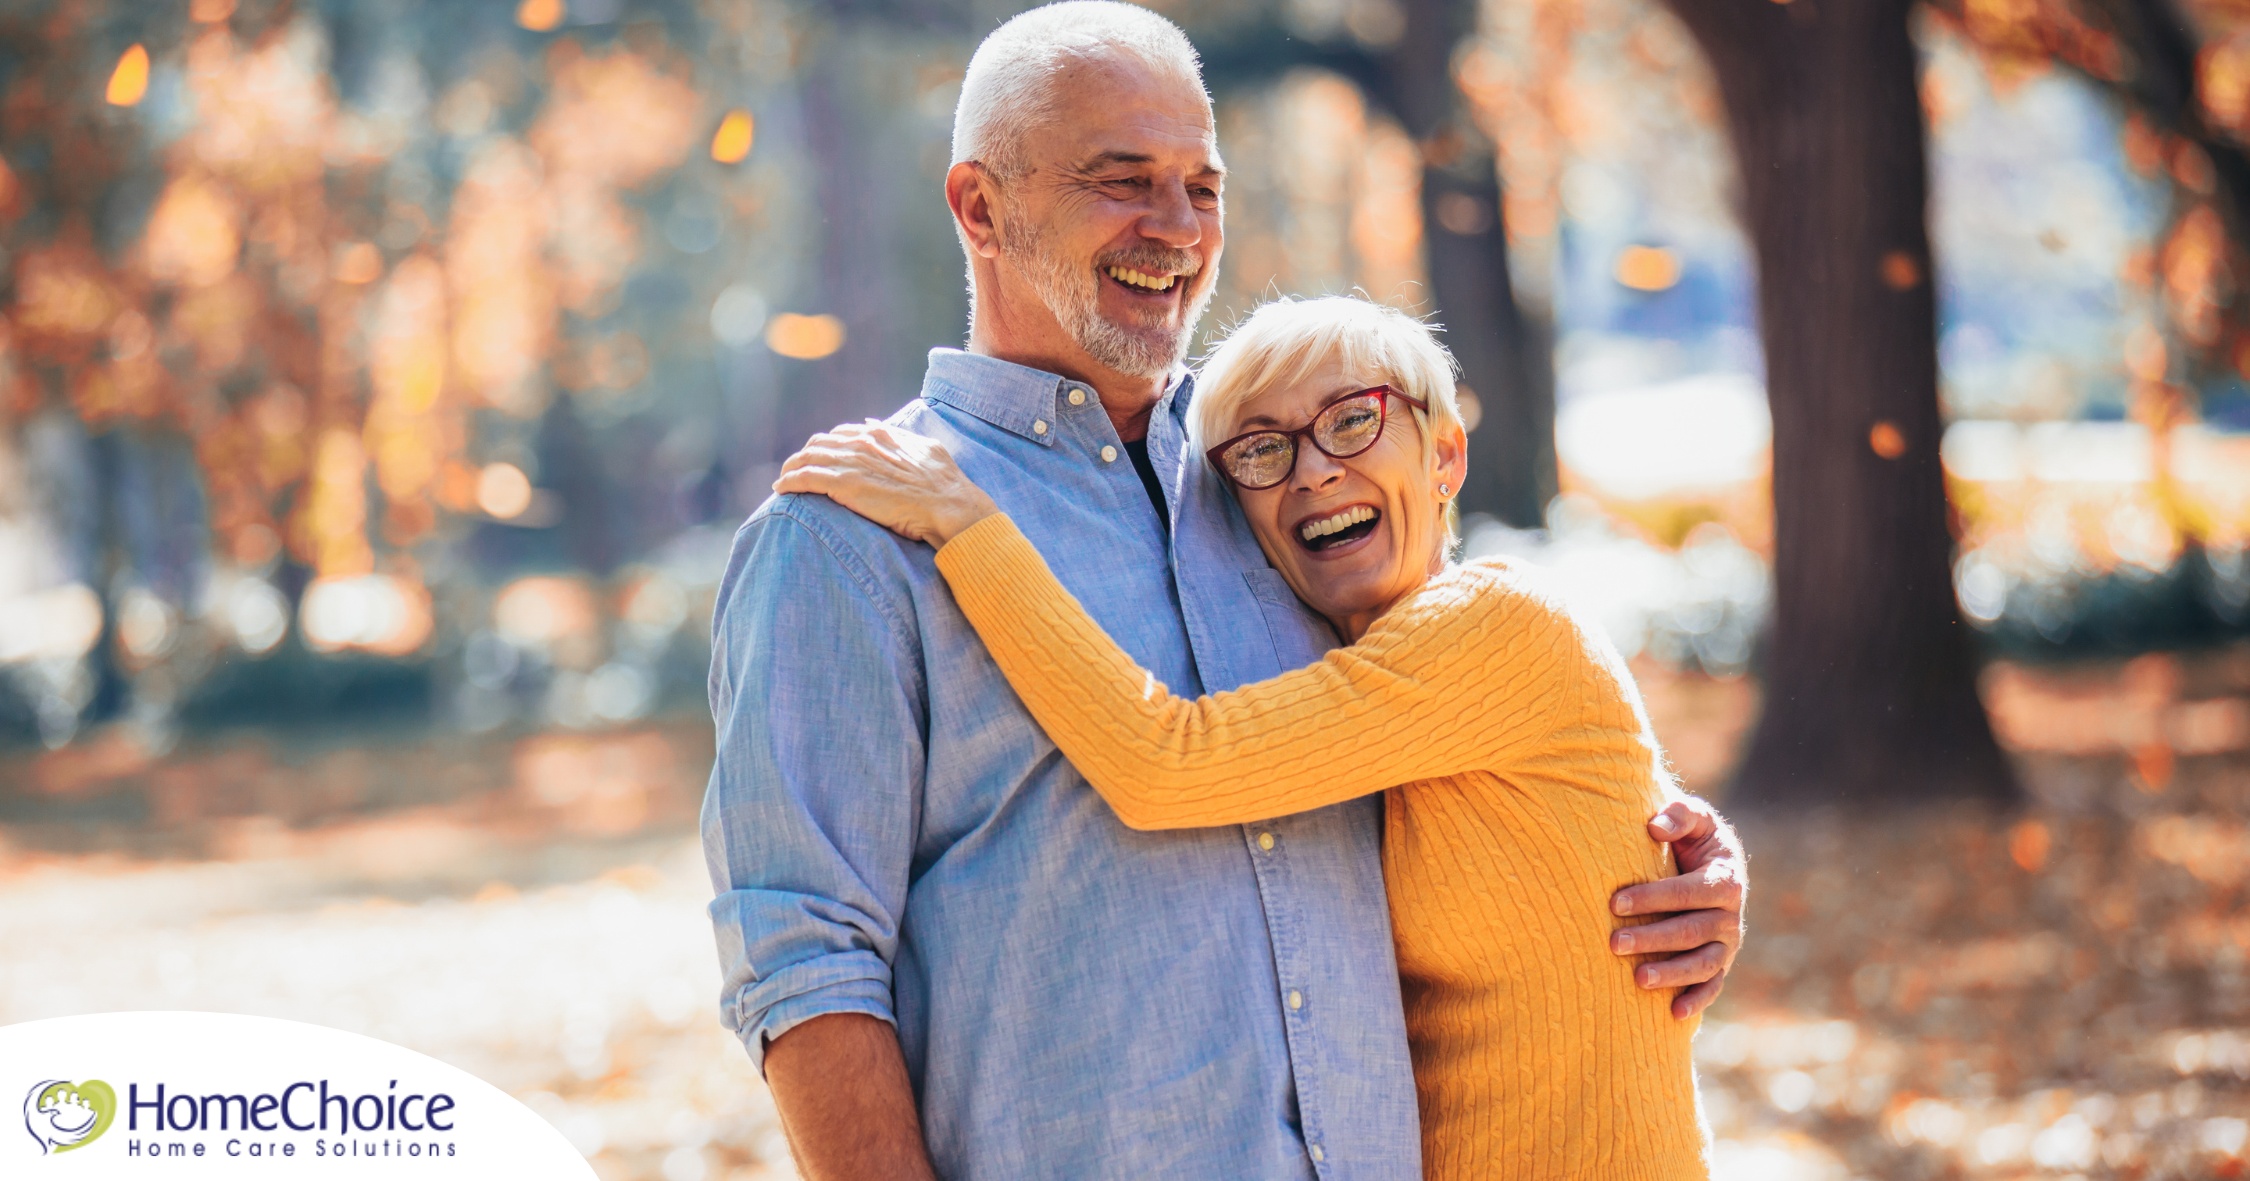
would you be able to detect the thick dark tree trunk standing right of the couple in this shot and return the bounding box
[1667,0,2014,803]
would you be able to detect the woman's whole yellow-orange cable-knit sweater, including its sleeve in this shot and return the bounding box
[938,515,1708,1181]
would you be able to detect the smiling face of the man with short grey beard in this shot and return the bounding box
[1001,56,1224,378]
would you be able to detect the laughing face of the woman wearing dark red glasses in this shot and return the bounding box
[1226,360,1467,641]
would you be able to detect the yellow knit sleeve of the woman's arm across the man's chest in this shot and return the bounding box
[938,515,1589,828]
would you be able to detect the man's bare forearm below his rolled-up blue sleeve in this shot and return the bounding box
[765,1012,938,1181]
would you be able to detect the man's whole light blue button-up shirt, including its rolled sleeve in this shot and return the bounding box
[702,349,1422,1181]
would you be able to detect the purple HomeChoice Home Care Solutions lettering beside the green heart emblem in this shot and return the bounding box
[110,1078,461,1161]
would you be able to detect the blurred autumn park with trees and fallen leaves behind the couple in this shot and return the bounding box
[13,0,2250,1181]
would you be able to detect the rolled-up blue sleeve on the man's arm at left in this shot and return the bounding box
[702,497,925,1069]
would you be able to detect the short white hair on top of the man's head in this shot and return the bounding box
[954,0,1211,180]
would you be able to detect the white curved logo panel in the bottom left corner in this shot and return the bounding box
[0,1012,594,1181]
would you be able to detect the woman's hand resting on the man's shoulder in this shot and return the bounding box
[774,421,999,544]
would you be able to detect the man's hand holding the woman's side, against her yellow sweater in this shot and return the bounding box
[1609,796,1751,1019]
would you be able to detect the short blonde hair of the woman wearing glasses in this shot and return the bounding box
[1188,295,1463,476]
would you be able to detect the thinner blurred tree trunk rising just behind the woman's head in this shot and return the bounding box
[1384,0,1555,529]
